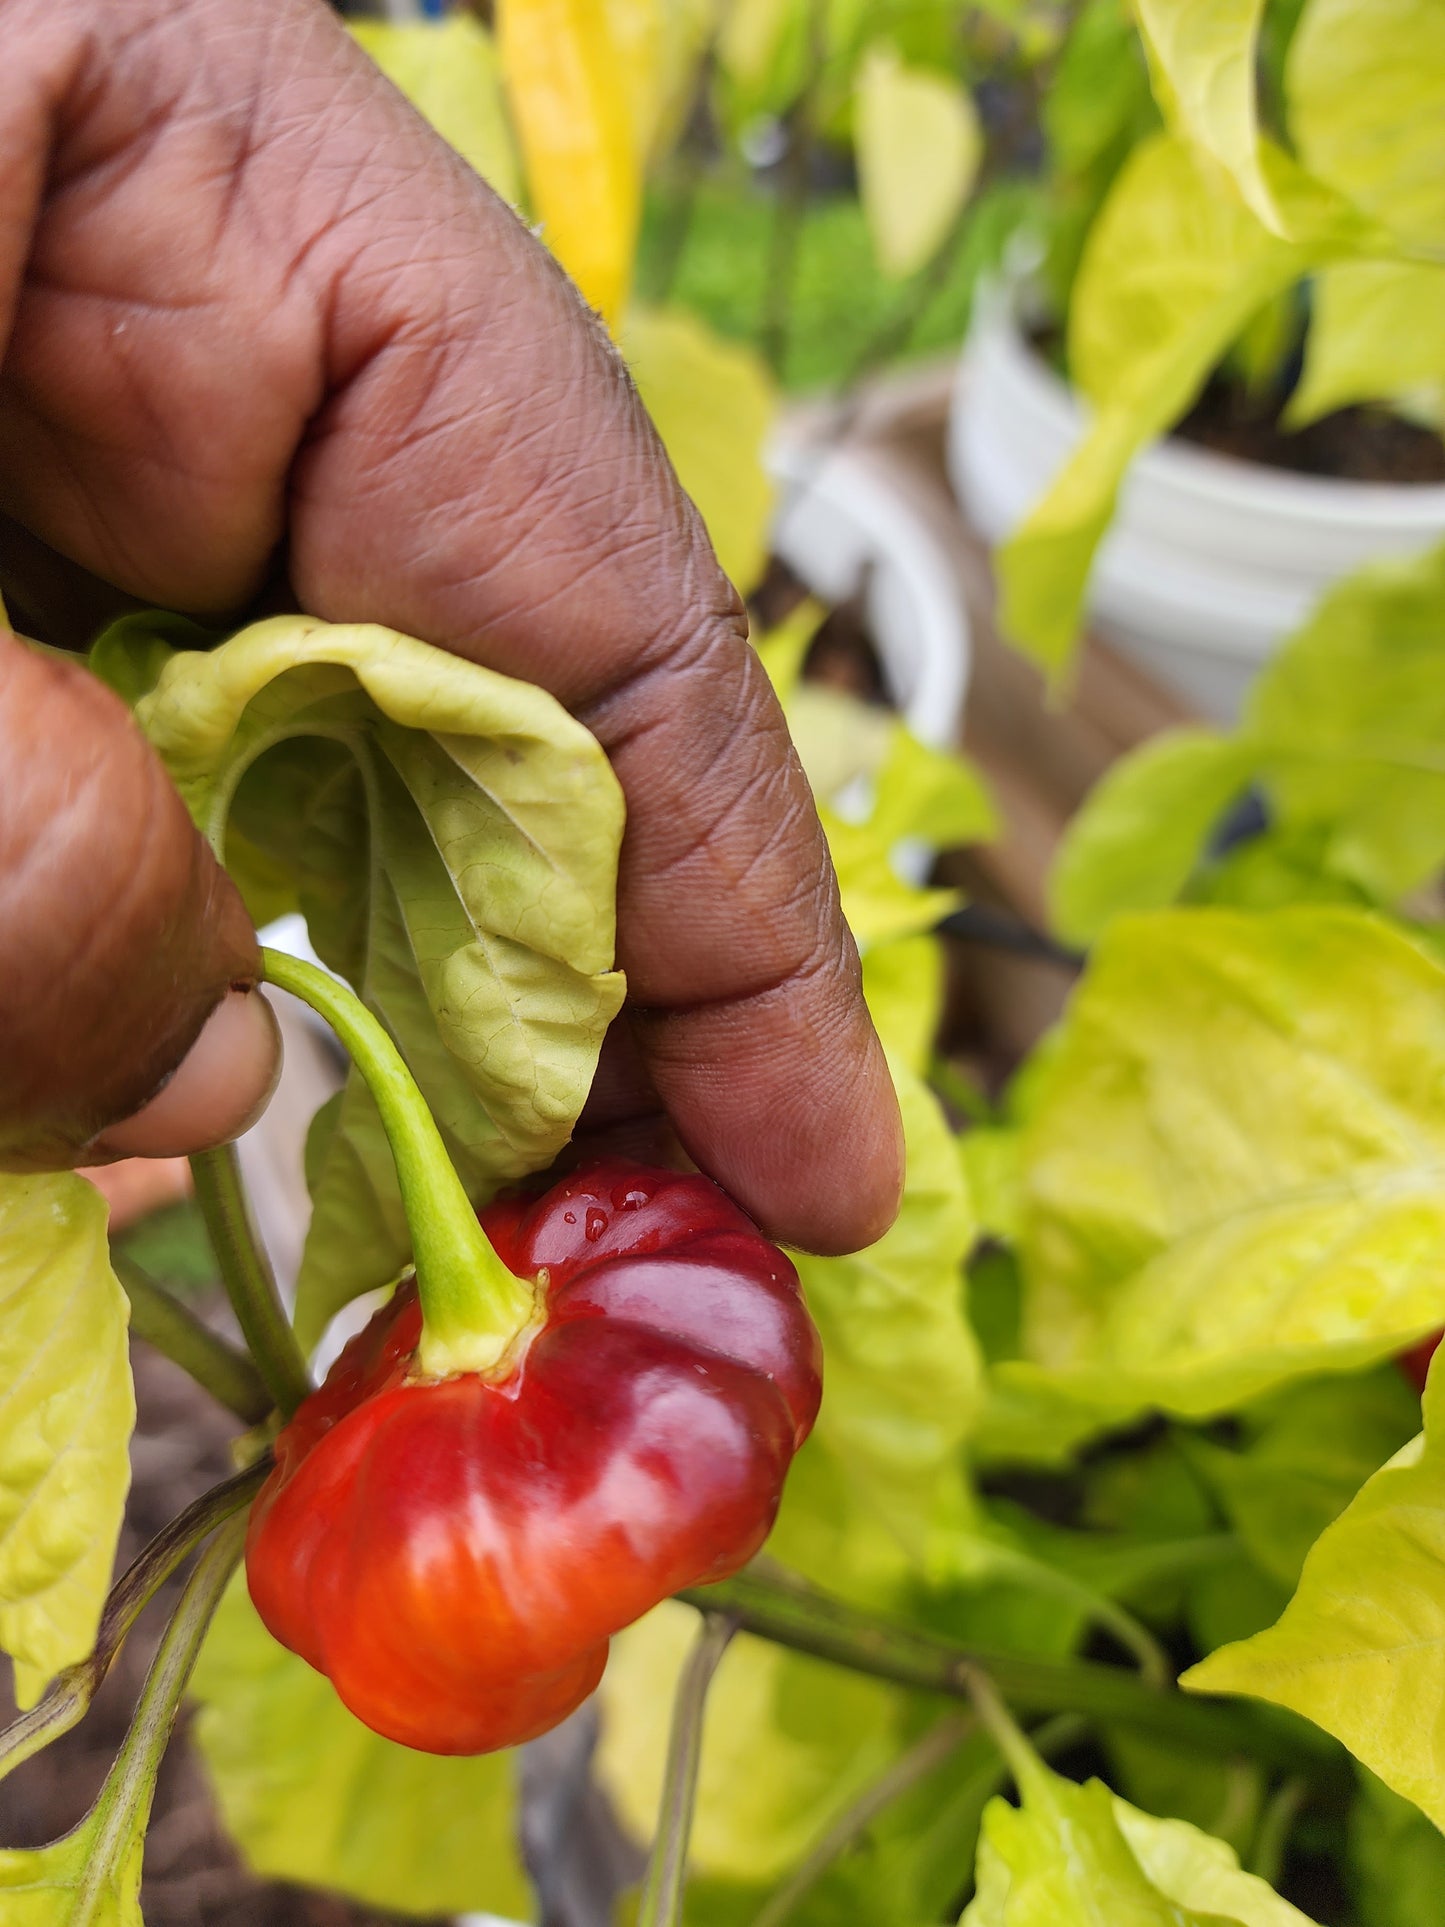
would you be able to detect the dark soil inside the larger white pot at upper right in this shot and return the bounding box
[1175,382,1445,484]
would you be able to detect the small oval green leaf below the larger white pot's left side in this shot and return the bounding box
[1050,728,1254,944]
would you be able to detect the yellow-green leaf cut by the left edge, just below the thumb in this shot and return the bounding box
[0,1172,135,1703]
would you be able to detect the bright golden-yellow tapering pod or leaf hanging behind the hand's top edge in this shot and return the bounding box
[497,0,642,330]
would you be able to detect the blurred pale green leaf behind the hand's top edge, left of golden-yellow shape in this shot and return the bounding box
[351,10,522,202]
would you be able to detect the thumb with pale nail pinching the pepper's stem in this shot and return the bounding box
[0,628,279,1172]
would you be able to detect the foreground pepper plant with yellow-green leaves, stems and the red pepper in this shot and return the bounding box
[0,0,1445,1927]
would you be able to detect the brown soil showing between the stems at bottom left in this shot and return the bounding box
[0,1343,446,1927]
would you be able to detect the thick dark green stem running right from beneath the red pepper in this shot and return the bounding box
[678,1567,1341,1779]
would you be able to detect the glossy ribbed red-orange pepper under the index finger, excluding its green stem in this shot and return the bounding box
[247,1160,821,1754]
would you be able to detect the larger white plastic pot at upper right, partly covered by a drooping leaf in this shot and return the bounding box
[948,289,1445,721]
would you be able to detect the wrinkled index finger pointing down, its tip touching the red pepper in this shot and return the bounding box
[293,48,902,1251]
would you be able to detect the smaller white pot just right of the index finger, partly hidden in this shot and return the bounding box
[769,426,969,750]
